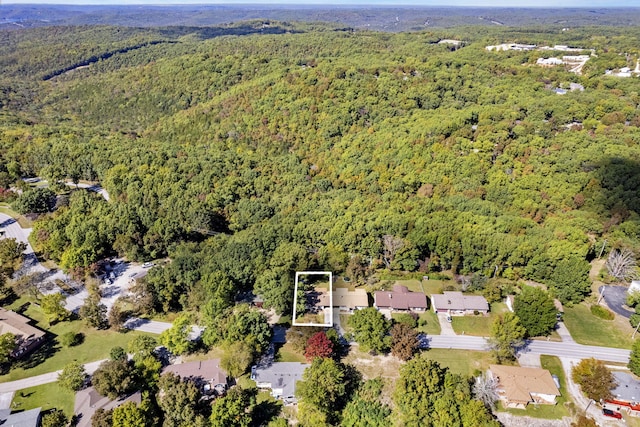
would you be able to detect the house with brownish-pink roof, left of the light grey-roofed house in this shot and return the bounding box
[162,359,227,396]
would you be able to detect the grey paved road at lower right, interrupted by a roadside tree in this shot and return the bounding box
[429,335,631,363]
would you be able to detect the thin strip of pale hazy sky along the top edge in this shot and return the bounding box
[0,0,640,7]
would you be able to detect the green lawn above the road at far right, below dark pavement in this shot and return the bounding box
[564,303,633,348]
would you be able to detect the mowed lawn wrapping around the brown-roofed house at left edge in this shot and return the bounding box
[0,299,153,382]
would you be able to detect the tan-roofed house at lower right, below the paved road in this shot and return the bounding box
[489,365,560,409]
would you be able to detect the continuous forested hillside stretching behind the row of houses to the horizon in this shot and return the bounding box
[0,22,640,311]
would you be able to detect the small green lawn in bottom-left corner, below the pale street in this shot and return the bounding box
[11,383,76,417]
